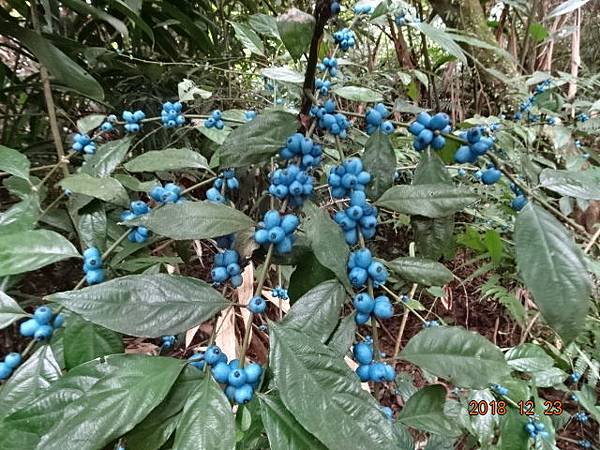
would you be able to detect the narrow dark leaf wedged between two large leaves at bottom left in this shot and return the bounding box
[125,366,203,450]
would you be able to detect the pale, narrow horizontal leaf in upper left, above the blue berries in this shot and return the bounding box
[125,148,208,172]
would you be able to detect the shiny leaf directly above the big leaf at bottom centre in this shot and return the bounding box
[281,280,346,343]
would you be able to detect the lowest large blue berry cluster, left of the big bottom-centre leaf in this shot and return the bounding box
[189,345,263,405]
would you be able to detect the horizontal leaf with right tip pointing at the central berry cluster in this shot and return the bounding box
[127,201,254,240]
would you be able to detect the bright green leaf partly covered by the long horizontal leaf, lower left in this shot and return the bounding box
[63,314,125,370]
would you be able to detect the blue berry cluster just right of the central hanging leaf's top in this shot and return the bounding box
[334,191,377,245]
